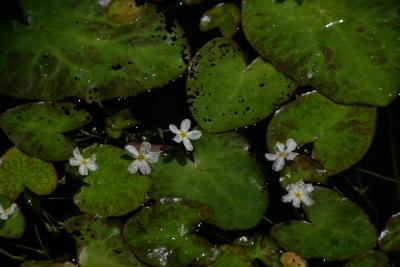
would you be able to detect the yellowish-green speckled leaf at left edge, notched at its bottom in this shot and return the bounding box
[0,147,57,200]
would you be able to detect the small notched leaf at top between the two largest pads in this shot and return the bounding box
[200,3,240,39]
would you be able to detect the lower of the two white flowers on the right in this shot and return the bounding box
[282,180,314,208]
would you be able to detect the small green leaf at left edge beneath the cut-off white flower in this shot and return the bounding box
[0,197,25,238]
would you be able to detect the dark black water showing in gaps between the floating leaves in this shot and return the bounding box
[0,0,400,267]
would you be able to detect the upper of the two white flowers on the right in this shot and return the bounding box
[265,138,298,172]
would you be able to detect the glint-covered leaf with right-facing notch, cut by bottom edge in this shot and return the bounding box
[123,199,217,267]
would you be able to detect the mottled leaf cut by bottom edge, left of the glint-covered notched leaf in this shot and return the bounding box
[65,215,146,267]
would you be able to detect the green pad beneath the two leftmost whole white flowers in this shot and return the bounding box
[74,145,151,217]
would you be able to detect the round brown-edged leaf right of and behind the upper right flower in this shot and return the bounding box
[267,92,376,175]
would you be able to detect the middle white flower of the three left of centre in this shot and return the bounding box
[125,142,160,175]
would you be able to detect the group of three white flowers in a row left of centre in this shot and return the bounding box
[69,119,201,176]
